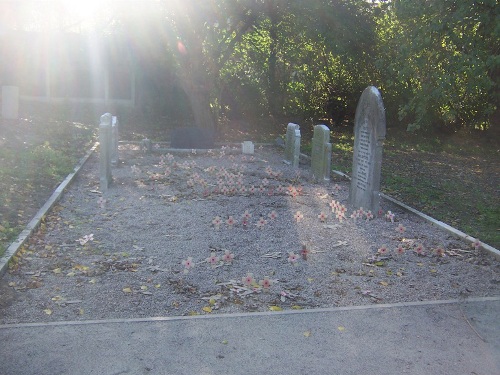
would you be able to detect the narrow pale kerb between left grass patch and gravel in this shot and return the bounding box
[0,142,99,278]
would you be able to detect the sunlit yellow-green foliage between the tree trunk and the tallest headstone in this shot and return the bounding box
[219,0,375,121]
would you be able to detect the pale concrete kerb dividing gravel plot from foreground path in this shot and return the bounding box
[0,296,500,330]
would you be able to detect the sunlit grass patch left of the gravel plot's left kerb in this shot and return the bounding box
[0,119,95,255]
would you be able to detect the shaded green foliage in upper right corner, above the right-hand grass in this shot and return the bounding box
[377,0,500,130]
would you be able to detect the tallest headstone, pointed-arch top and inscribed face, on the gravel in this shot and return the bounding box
[349,86,386,212]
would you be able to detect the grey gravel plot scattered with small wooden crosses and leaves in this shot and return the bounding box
[0,145,500,324]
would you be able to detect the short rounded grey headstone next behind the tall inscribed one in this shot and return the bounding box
[311,125,332,182]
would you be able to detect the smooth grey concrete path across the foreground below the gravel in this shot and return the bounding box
[0,297,500,375]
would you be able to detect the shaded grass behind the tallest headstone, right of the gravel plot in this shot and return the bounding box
[332,128,500,248]
